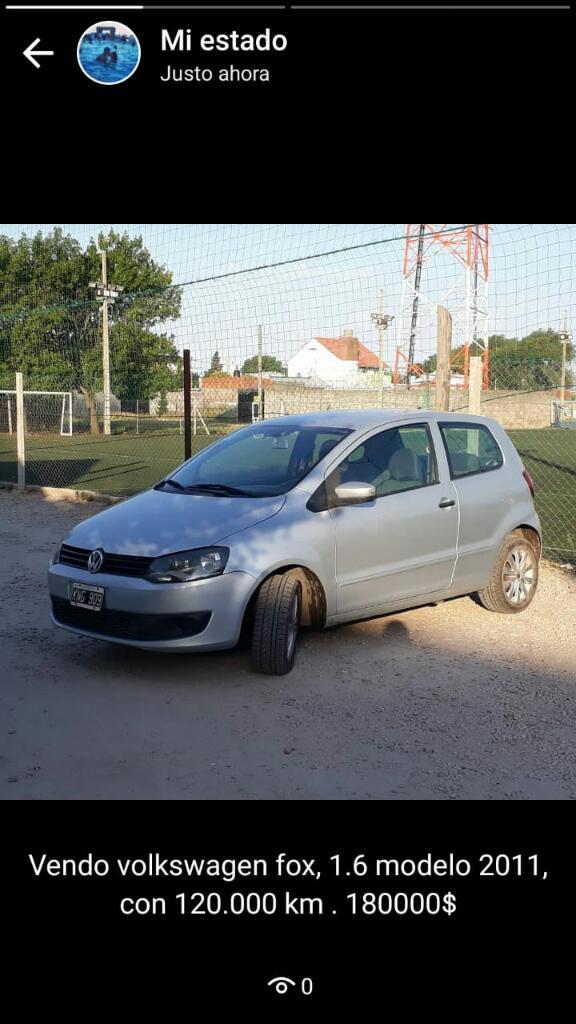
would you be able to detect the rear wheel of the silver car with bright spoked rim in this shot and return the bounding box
[478,529,538,615]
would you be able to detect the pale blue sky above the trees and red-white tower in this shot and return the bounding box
[0,224,576,370]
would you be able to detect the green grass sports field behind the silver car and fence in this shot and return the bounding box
[0,426,576,559]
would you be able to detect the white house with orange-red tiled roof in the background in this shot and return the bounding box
[288,334,378,386]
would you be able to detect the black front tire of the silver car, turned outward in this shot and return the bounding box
[252,572,302,676]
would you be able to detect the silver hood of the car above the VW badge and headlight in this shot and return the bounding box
[65,490,286,558]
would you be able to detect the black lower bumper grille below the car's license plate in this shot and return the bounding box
[52,597,211,642]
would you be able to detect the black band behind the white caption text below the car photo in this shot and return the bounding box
[3,802,574,1020]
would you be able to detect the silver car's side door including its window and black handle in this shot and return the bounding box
[325,422,458,615]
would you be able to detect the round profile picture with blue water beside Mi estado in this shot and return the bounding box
[78,22,140,85]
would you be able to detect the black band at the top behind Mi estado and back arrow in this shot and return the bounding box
[0,0,573,199]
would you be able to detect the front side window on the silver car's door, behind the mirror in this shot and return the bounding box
[326,423,438,498]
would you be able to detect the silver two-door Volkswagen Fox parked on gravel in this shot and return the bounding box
[48,410,541,675]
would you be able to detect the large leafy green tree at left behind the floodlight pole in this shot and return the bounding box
[0,228,181,433]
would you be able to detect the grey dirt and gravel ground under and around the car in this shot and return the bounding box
[0,492,576,800]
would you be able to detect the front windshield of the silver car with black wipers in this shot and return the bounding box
[157,423,351,498]
